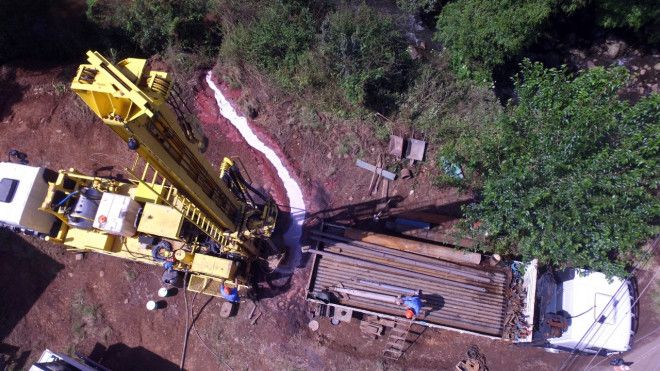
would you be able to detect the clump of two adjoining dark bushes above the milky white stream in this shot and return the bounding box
[220,1,410,111]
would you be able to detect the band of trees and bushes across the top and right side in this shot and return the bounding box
[0,0,660,276]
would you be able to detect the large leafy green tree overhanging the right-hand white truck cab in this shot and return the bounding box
[466,61,660,274]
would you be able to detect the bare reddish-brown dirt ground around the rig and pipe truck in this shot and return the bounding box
[0,61,658,371]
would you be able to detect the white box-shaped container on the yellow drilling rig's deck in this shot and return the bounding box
[94,192,140,237]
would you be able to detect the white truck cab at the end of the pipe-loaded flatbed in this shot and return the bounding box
[527,269,639,355]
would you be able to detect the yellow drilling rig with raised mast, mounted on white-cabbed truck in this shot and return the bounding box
[0,51,278,296]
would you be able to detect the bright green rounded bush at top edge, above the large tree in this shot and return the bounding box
[435,0,553,82]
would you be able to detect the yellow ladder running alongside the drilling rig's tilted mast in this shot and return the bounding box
[127,158,230,247]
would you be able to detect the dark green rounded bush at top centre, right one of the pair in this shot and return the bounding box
[321,5,410,112]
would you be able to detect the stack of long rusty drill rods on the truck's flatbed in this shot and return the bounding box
[309,230,510,337]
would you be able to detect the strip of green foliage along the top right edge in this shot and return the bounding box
[436,0,660,82]
